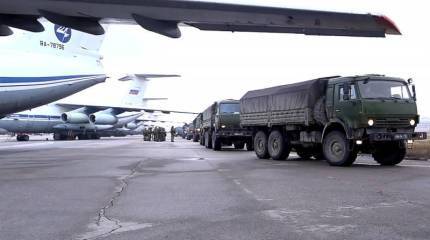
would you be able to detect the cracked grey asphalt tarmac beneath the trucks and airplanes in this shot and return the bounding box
[0,138,430,240]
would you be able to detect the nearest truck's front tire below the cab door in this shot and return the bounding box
[323,130,357,167]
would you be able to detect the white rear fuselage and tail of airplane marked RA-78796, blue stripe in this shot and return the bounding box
[0,19,106,118]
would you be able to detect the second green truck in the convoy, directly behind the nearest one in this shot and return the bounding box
[202,100,253,151]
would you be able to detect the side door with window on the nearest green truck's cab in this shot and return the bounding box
[334,83,360,127]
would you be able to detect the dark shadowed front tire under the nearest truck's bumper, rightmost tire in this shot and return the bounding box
[372,142,406,166]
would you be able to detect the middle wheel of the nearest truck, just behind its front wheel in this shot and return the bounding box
[267,130,291,160]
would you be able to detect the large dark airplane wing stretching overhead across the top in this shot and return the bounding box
[0,0,401,38]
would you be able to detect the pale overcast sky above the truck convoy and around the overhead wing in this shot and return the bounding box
[62,0,430,123]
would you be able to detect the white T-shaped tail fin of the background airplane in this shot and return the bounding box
[119,74,180,106]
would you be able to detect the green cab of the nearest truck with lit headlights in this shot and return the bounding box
[322,75,426,165]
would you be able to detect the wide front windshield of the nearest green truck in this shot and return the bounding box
[358,80,411,99]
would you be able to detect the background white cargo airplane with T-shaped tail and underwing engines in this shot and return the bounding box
[0,74,193,141]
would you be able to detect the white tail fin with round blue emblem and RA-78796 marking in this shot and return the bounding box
[6,18,105,60]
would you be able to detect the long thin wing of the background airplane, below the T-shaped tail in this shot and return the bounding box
[56,103,199,114]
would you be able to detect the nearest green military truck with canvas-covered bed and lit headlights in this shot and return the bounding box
[240,75,427,166]
